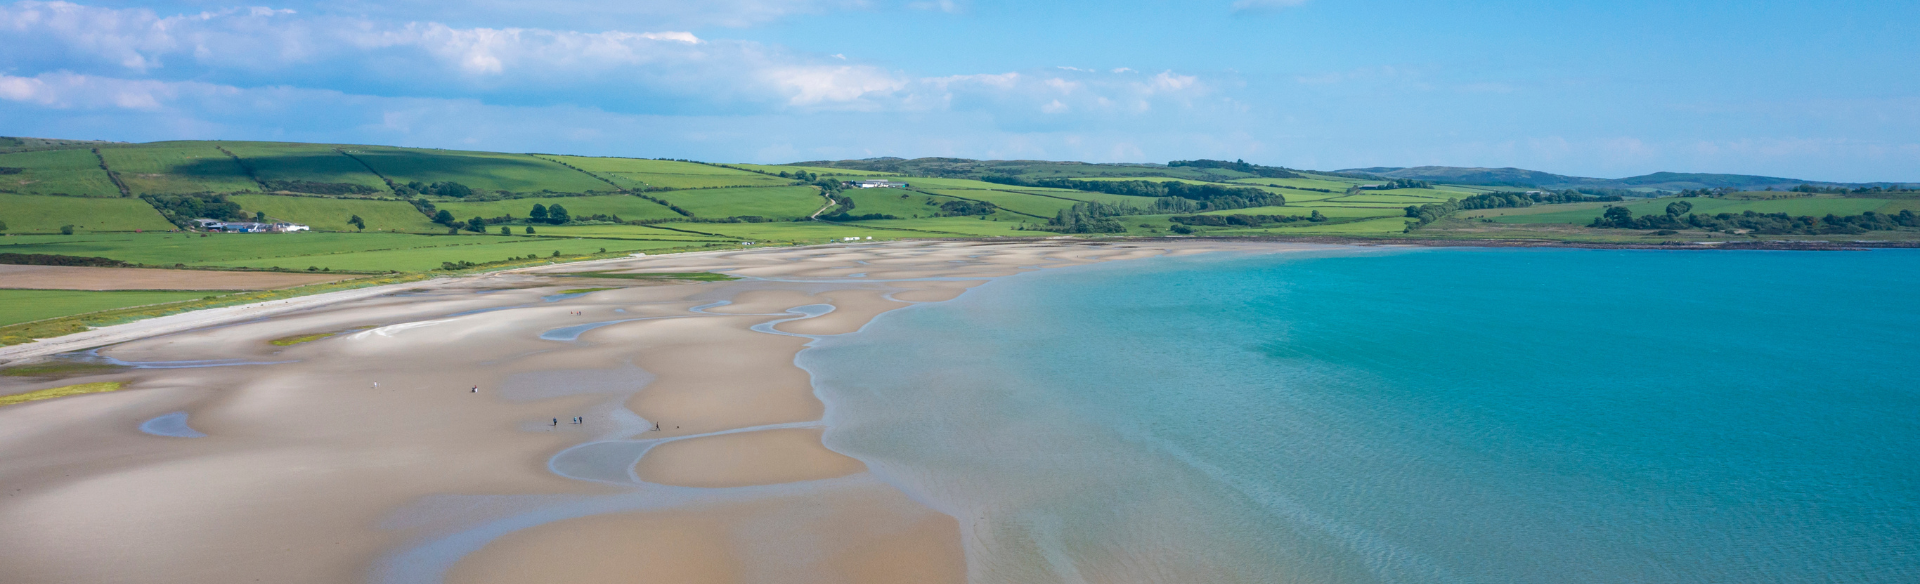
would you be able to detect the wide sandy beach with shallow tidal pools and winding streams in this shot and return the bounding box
[0,242,1300,582]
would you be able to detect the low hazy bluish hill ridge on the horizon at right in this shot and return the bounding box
[1336,167,1891,190]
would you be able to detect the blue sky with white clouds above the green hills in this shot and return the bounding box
[0,0,1920,181]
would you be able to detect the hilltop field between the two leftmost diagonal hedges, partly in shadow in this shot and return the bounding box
[100,142,259,194]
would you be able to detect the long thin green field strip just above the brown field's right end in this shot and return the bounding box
[211,236,703,271]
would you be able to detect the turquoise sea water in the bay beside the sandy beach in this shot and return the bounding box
[799,250,1920,582]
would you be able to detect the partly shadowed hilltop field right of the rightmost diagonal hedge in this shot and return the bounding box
[344,146,612,192]
